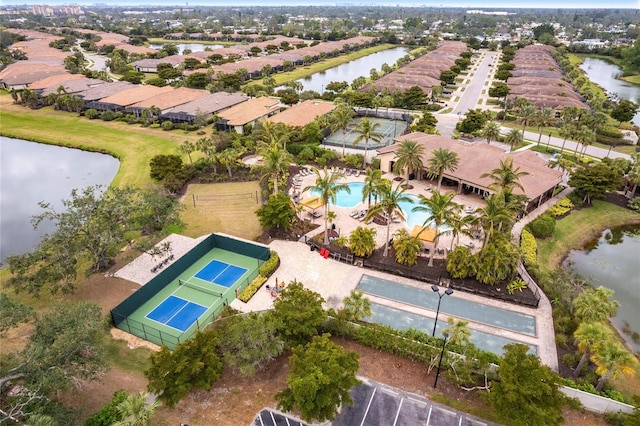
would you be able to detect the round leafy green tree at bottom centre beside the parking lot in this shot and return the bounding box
[276,334,360,422]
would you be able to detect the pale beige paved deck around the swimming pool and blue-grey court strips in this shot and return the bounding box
[231,174,558,371]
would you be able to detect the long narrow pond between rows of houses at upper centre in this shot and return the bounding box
[288,47,409,94]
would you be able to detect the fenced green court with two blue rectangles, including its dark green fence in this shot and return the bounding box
[111,234,269,349]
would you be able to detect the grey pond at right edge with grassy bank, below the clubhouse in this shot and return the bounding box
[565,226,640,352]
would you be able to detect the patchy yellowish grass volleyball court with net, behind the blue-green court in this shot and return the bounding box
[182,182,262,240]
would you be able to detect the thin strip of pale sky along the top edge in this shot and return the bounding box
[1,0,640,10]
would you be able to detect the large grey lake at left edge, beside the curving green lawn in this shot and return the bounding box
[0,136,120,266]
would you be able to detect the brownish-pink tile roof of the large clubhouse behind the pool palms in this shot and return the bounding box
[378,132,562,200]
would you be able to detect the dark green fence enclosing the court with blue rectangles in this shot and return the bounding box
[111,234,270,349]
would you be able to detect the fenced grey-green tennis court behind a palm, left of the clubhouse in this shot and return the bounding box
[323,117,408,149]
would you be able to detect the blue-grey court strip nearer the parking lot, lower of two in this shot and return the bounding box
[365,303,538,356]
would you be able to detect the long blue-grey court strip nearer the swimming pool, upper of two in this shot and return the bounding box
[357,275,536,336]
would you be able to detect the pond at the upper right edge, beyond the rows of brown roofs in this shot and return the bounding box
[580,57,640,126]
